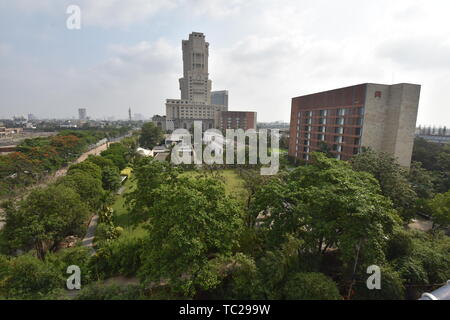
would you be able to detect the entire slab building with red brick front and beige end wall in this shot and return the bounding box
[289,83,420,167]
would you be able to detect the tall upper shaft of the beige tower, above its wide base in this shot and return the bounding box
[180,32,211,104]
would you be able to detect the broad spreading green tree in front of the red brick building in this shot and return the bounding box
[253,153,400,263]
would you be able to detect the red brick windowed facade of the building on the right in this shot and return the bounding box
[289,85,366,160]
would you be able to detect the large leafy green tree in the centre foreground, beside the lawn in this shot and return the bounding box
[141,177,242,297]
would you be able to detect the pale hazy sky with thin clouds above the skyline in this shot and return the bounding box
[0,0,450,125]
